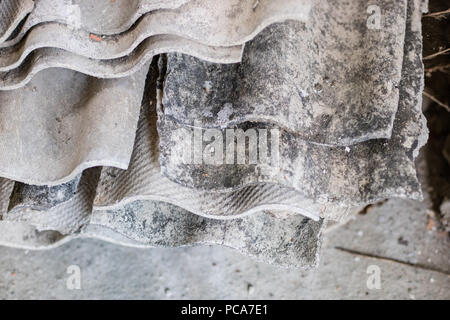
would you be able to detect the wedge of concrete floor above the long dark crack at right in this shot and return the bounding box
[327,199,450,274]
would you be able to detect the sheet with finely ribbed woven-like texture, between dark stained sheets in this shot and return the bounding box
[94,96,347,221]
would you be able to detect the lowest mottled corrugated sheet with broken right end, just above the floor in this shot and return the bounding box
[87,201,325,268]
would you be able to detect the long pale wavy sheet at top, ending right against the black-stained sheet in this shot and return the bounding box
[0,0,310,71]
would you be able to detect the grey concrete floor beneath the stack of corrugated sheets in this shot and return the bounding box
[0,195,450,299]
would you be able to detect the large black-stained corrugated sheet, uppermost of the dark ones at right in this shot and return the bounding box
[163,0,406,146]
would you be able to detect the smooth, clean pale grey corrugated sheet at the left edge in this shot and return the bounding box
[0,66,148,185]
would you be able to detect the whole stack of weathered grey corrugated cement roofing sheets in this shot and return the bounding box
[0,0,427,268]
